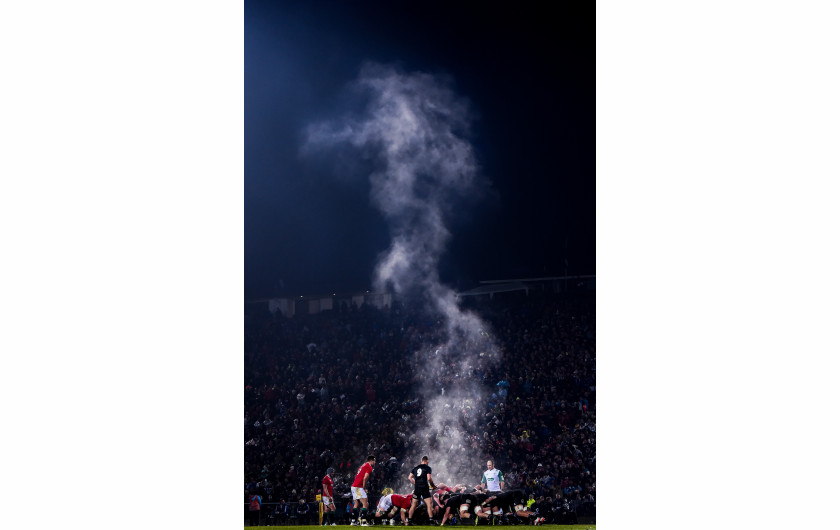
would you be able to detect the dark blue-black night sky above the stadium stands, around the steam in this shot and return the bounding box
[245,0,595,299]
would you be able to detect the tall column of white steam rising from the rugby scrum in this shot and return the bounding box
[305,65,499,489]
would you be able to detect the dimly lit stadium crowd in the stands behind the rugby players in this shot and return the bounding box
[244,286,595,524]
